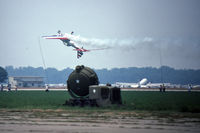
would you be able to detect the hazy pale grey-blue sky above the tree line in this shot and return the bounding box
[0,0,200,70]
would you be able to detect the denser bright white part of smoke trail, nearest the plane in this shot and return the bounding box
[65,34,153,49]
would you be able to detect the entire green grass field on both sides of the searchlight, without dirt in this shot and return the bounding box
[0,91,200,113]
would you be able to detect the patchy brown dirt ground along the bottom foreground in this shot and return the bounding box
[0,109,200,133]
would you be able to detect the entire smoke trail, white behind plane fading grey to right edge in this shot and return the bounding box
[65,34,200,62]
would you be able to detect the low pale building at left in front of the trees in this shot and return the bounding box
[8,76,44,87]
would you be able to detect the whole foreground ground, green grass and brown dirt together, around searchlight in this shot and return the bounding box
[0,88,200,133]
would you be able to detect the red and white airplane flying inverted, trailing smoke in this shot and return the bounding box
[42,30,103,58]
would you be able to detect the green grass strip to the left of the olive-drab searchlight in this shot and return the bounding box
[0,91,69,109]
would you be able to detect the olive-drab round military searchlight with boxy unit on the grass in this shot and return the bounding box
[66,66,121,106]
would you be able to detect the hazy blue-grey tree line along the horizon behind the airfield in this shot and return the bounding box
[2,66,200,84]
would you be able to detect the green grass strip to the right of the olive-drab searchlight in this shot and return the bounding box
[122,91,200,112]
